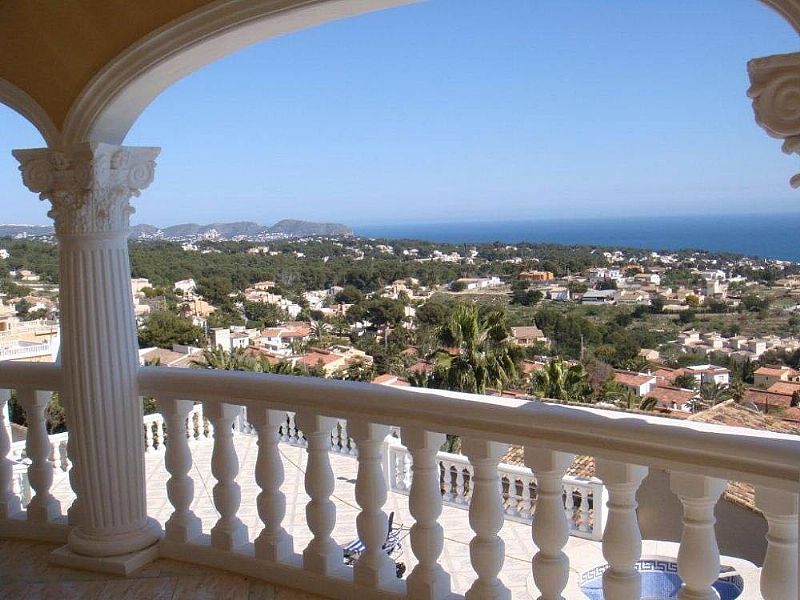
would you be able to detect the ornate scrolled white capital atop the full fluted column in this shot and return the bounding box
[12,142,160,235]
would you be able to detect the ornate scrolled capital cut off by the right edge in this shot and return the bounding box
[747,52,800,188]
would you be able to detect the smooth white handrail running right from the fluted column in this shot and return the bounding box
[139,367,800,491]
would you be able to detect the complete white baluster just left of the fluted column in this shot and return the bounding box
[17,388,61,521]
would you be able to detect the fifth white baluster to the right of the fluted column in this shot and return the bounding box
[350,420,396,588]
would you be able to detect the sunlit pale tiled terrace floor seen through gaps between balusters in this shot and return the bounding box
[34,434,758,600]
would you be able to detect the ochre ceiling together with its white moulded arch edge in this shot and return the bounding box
[0,0,800,145]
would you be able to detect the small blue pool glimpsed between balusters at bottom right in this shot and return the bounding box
[581,560,744,600]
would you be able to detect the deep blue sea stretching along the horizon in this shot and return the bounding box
[354,213,800,261]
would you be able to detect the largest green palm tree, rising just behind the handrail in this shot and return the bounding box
[436,305,517,394]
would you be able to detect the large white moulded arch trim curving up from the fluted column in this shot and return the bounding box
[63,0,800,144]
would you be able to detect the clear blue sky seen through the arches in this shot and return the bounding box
[0,0,800,225]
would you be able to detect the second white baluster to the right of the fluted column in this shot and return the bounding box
[205,403,247,551]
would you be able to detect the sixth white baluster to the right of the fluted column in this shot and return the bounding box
[401,428,450,600]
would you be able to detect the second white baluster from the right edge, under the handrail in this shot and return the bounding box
[670,471,727,600]
